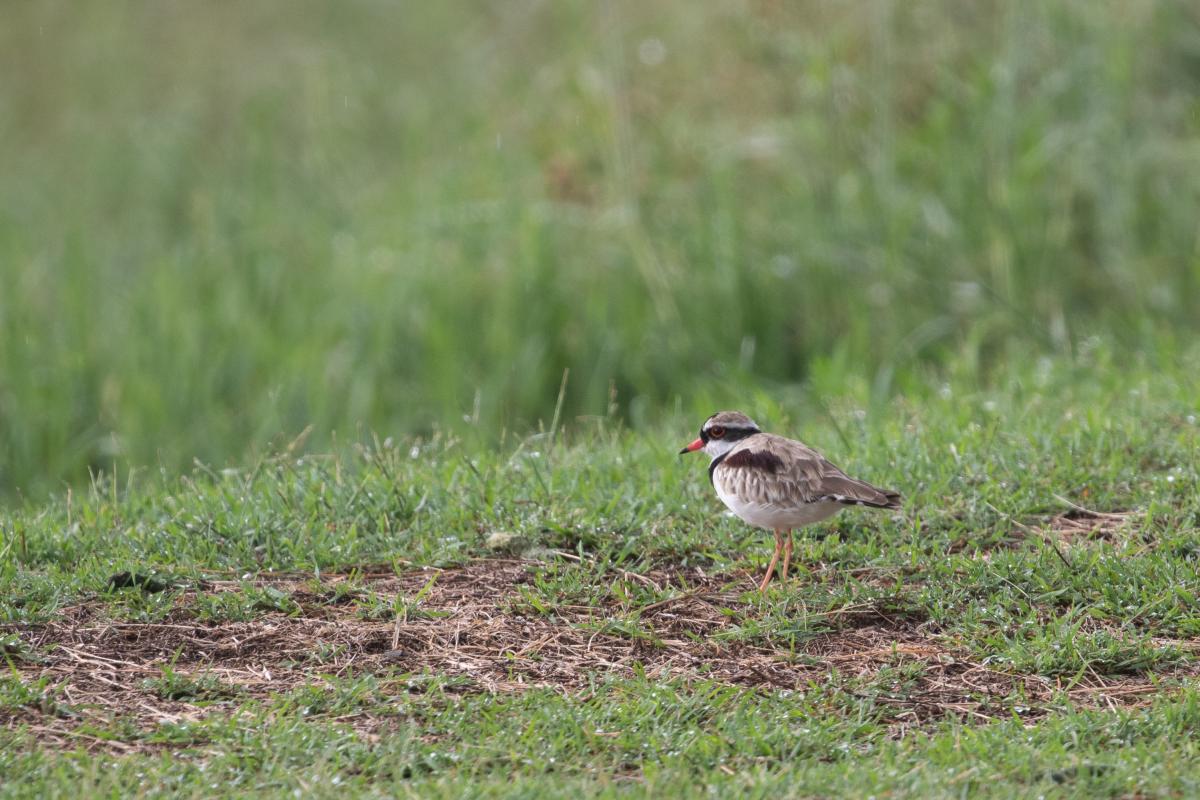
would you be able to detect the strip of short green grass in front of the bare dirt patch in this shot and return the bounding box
[7,681,1200,798]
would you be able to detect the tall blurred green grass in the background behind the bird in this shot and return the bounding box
[0,0,1200,492]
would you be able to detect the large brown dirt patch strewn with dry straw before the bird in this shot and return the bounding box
[0,559,1190,750]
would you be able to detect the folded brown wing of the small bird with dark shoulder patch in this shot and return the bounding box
[715,433,900,509]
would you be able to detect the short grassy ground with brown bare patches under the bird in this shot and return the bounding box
[0,351,1200,798]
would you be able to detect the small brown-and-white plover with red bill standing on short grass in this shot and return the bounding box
[679,411,900,591]
